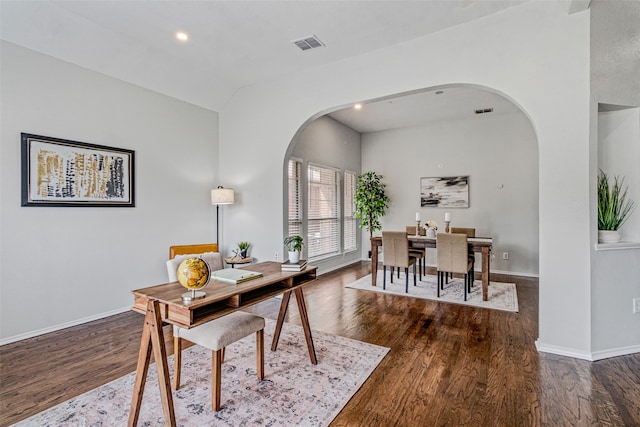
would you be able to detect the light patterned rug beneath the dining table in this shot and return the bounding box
[347,270,518,312]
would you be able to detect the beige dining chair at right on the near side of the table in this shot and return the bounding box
[436,233,473,301]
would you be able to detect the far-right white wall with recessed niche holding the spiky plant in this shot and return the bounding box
[590,0,640,359]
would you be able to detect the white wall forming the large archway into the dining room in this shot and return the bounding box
[220,2,592,357]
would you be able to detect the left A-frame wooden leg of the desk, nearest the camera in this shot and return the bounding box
[127,301,176,427]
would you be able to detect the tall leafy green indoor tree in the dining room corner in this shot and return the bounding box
[354,172,389,260]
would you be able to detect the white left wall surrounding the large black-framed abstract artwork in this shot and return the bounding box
[0,42,218,342]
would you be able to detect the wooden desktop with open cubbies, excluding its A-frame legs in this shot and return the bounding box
[132,262,318,328]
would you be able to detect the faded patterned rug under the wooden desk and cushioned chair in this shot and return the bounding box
[15,319,389,427]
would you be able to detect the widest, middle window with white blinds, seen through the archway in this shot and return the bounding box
[307,164,340,259]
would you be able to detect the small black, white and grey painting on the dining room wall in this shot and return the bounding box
[420,176,469,208]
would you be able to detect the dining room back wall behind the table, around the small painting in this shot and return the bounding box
[362,113,539,275]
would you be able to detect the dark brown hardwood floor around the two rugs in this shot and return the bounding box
[0,263,640,426]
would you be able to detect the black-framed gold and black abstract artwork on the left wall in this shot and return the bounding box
[21,133,135,207]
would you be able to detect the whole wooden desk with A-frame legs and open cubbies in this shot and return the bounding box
[128,262,318,426]
